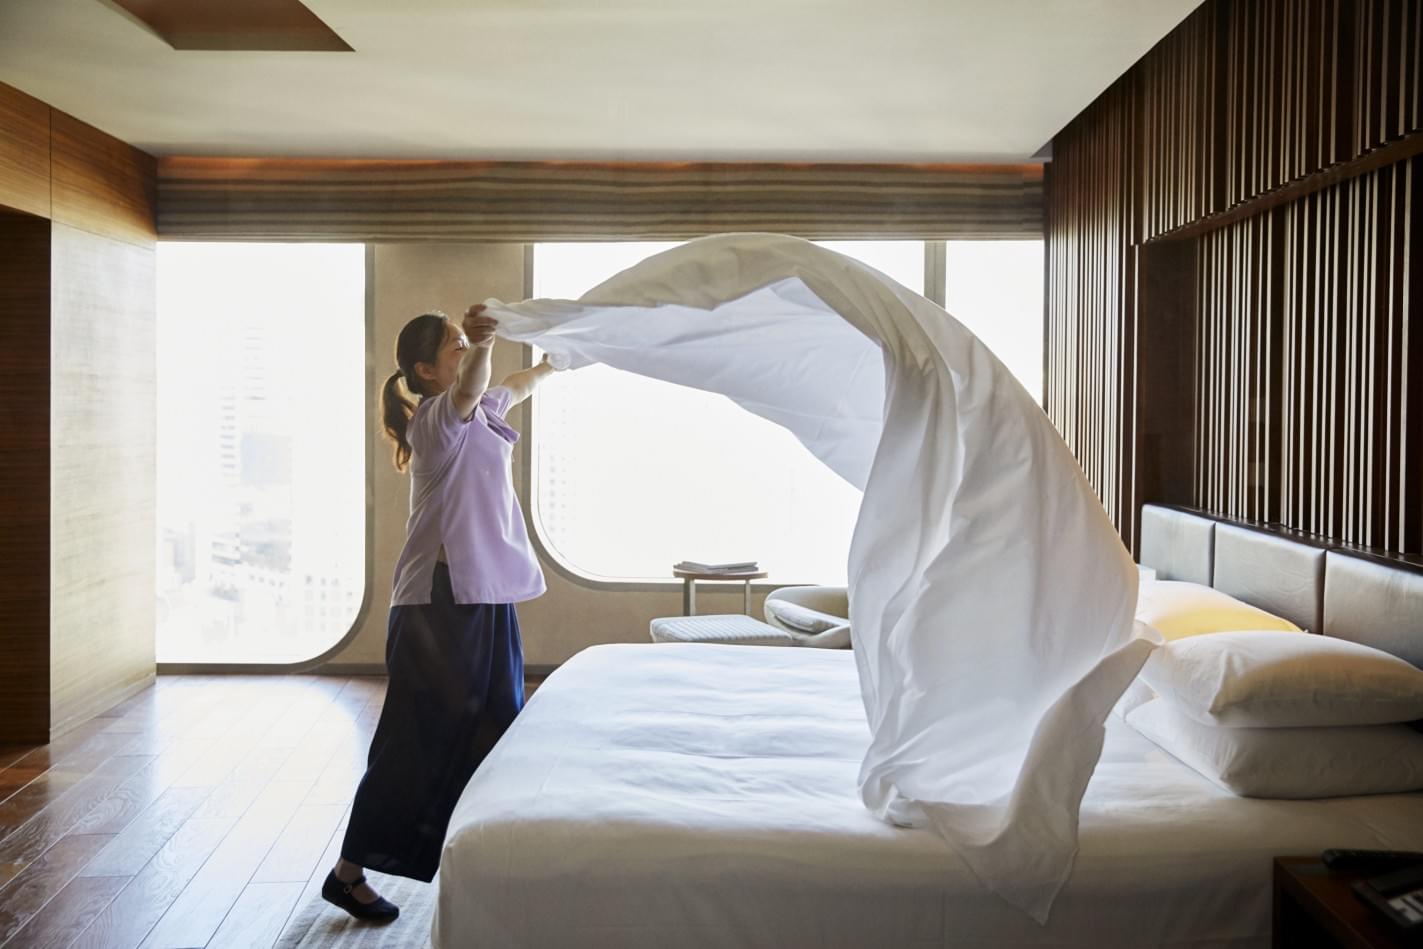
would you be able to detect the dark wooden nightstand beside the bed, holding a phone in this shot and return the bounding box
[1271,857,1423,949]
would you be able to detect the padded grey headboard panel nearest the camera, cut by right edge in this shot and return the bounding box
[1323,551,1423,667]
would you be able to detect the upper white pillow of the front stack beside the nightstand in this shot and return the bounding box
[1141,630,1423,728]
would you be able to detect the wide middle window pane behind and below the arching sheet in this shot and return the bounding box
[534,240,924,583]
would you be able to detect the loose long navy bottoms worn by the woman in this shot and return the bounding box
[342,563,524,882]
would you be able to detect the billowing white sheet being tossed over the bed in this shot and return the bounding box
[490,235,1151,921]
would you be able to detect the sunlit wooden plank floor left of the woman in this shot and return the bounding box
[0,676,398,949]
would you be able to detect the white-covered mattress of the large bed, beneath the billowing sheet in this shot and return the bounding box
[431,645,1423,949]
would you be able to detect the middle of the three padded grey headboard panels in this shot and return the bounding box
[1211,524,1325,633]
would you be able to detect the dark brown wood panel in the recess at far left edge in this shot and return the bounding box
[0,212,50,744]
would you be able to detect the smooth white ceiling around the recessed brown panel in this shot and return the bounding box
[0,0,1198,162]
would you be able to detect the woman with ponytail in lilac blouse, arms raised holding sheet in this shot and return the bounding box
[322,306,554,922]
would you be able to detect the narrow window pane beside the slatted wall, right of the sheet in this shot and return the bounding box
[943,240,1043,403]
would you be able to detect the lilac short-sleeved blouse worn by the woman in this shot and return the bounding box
[390,386,545,606]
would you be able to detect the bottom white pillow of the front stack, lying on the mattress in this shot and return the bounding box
[1127,699,1423,798]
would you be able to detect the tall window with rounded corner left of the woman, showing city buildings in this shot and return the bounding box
[157,242,370,663]
